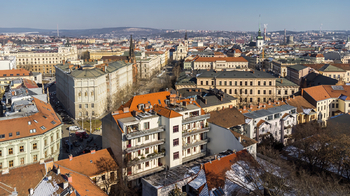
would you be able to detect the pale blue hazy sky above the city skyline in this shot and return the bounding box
[0,0,350,31]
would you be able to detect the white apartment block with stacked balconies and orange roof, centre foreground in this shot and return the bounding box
[102,91,210,186]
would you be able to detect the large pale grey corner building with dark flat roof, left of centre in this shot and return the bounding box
[56,61,135,119]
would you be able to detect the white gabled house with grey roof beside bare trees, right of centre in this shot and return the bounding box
[240,102,297,144]
